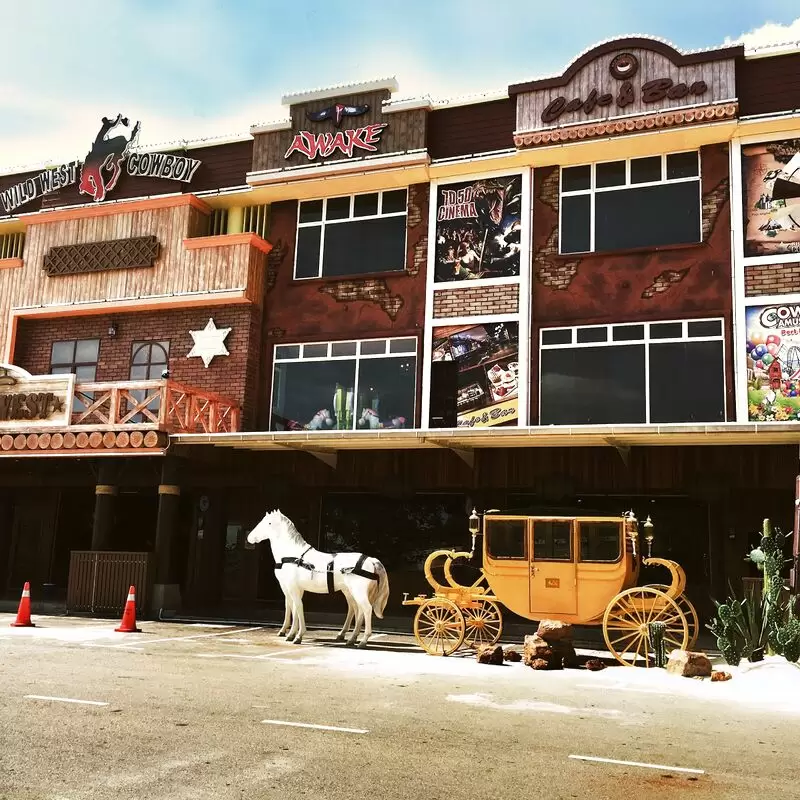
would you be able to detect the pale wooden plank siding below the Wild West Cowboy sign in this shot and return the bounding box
[0,198,266,360]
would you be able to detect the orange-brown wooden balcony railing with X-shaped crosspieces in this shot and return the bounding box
[72,380,241,433]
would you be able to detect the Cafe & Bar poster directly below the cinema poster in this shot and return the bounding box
[432,322,520,428]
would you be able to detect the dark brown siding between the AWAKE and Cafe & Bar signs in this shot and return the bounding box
[428,99,516,159]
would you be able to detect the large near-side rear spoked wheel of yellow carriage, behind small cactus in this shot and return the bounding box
[603,586,689,667]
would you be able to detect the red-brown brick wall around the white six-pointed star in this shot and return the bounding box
[13,305,261,427]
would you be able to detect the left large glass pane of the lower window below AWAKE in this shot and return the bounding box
[272,359,356,431]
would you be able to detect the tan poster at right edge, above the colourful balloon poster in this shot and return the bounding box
[742,139,800,257]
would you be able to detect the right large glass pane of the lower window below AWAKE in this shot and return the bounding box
[356,358,416,428]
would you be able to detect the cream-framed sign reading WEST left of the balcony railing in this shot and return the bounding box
[0,364,75,430]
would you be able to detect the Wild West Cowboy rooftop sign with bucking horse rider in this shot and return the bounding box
[0,114,201,214]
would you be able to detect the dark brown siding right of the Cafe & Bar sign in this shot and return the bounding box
[736,53,800,117]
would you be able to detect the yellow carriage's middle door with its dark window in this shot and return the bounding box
[530,519,578,619]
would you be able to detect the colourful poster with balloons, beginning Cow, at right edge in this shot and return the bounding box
[745,303,800,422]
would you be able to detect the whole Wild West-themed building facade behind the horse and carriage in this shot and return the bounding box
[0,38,800,615]
